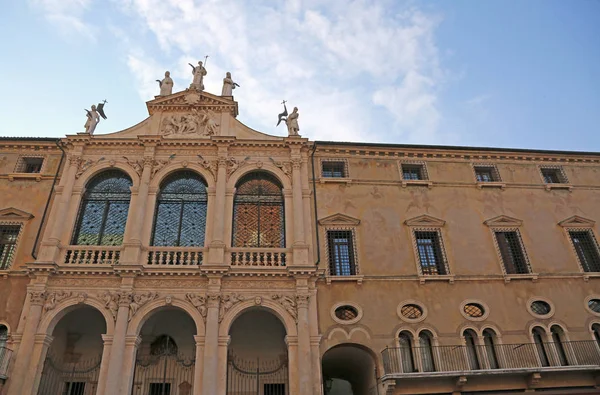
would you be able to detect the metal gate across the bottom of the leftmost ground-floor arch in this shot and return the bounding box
[38,354,102,395]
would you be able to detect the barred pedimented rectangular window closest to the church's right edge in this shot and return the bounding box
[327,230,356,276]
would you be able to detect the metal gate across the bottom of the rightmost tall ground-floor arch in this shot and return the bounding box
[227,353,289,395]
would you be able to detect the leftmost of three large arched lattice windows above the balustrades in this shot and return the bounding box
[72,170,133,246]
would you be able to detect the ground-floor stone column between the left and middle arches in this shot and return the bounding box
[105,291,131,395]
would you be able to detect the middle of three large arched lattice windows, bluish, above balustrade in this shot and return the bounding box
[152,171,207,247]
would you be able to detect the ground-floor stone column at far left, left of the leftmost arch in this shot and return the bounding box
[8,290,46,395]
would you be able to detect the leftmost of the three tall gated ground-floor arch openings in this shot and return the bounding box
[38,306,106,395]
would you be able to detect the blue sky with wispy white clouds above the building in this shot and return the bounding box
[0,0,600,151]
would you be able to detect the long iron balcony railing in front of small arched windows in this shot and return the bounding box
[382,340,600,377]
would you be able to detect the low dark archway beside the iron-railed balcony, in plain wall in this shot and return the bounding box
[322,344,377,395]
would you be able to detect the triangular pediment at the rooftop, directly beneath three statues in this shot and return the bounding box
[146,89,238,117]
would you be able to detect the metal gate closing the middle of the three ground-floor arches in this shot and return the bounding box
[131,336,196,395]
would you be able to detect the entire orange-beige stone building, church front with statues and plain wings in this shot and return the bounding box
[0,84,600,395]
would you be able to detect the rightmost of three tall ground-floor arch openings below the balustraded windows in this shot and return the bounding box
[227,309,289,395]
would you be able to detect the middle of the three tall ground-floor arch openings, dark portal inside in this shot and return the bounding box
[131,307,197,395]
